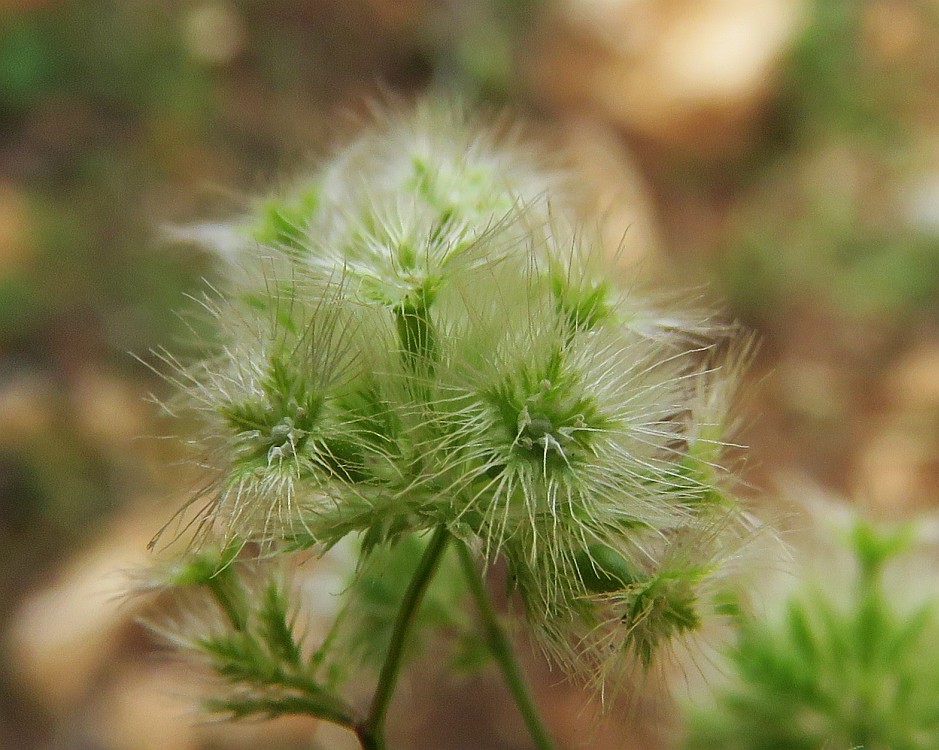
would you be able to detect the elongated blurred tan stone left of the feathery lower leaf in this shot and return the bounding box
[3,513,158,713]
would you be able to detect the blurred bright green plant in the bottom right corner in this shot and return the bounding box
[685,520,939,750]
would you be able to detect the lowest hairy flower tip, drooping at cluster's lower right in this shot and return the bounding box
[518,520,749,706]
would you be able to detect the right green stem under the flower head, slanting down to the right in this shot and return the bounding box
[457,542,554,750]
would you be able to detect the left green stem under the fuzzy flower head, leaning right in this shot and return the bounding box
[356,526,450,750]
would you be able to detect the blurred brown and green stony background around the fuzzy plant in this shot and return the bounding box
[0,0,939,750]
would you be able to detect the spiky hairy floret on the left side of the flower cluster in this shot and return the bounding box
[150,274,398,542]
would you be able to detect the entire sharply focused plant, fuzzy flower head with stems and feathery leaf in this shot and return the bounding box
[141,103,752,749]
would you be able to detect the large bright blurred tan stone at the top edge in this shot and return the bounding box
[533,0,805,154]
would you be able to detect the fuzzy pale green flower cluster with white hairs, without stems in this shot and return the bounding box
[167,104,746,696]
